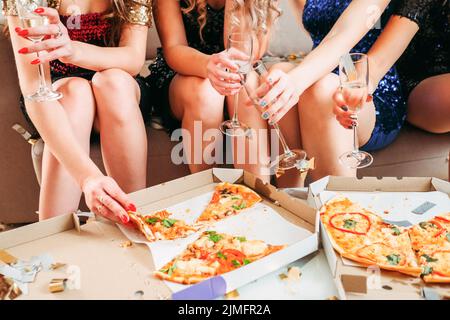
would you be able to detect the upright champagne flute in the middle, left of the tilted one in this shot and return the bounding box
[220,32,253,137]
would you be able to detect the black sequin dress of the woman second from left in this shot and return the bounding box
[147,0,225,131]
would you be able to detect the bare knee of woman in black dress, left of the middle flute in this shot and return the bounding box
[181,77,224,120]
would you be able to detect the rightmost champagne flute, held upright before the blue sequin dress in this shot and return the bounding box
[339,53,373,169]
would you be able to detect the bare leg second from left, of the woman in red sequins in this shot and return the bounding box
[92,69,147,193]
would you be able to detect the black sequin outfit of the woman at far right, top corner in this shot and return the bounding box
[394,0,450,95]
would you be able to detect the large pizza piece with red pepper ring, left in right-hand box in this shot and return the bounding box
[320,197,421,277]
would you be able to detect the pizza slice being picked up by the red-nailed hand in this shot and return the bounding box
[128,210,198,242]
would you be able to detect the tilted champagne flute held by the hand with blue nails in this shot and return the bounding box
[244,60,307,170]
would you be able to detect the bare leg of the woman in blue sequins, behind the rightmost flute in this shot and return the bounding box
[299,74,376,180]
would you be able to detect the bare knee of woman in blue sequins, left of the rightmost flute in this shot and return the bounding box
[299,74,339,117]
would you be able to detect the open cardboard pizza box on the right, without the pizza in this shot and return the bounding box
[308,176,450,300]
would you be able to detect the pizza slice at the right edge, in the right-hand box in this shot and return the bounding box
[409,213,450,283]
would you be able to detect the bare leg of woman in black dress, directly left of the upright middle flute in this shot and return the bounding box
[169,75,224,173]
